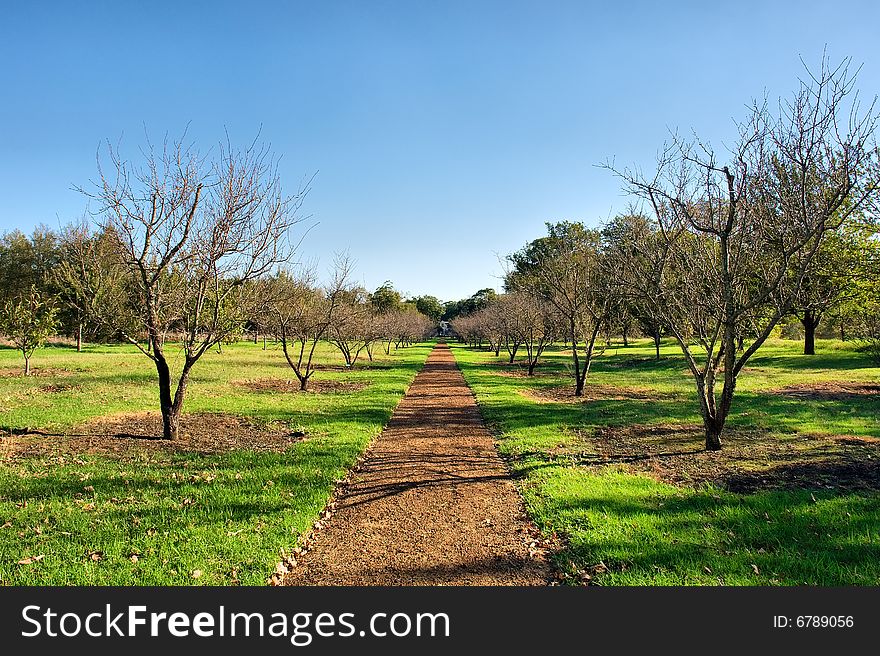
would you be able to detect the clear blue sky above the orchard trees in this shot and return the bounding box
[0,0,880,300]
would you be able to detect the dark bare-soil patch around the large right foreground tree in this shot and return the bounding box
[553,424,880,493]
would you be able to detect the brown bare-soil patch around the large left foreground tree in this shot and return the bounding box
[0,412,305,459]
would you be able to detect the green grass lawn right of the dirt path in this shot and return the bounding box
[454,340,880,586]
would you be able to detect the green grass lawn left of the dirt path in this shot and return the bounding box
[0,343,431,585]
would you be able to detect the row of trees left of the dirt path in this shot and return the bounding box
[0,141,433,439]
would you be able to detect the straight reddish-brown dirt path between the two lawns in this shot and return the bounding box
[284,344,550,585]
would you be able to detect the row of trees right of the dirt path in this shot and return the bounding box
[454,60,880,450]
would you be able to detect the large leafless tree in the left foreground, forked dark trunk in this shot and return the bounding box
[87,132,307,439]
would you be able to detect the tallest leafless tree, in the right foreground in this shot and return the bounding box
[609,58,878,450]
